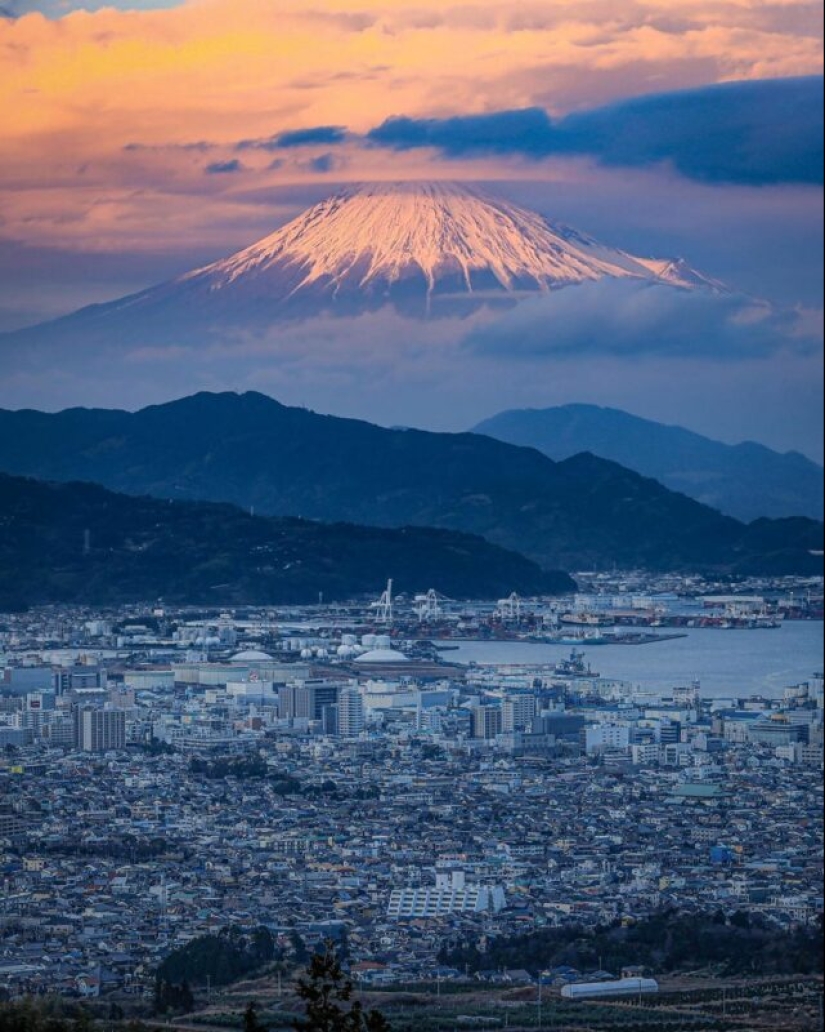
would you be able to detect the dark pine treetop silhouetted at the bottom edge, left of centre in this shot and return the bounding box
[292,942,390,1032]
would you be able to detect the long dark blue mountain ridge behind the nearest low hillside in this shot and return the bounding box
[0,392,821,573]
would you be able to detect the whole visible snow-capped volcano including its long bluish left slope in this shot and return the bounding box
[0,183,724,345]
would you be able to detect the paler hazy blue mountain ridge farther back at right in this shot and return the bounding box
[473,404,823,522]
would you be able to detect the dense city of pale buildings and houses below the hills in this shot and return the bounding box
[0,574,823,1029]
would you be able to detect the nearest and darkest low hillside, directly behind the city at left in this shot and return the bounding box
[0,475,575,609]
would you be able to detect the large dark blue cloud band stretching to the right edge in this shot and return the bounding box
[367,76,823,185]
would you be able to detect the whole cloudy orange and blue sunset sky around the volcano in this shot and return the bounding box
[0,0,823,457]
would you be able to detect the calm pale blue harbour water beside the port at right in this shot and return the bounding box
[443,620,823,699]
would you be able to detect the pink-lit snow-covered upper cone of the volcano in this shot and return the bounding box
[177,183,711,307]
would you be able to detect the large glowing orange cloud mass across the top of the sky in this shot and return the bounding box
[0,0,822,250]
